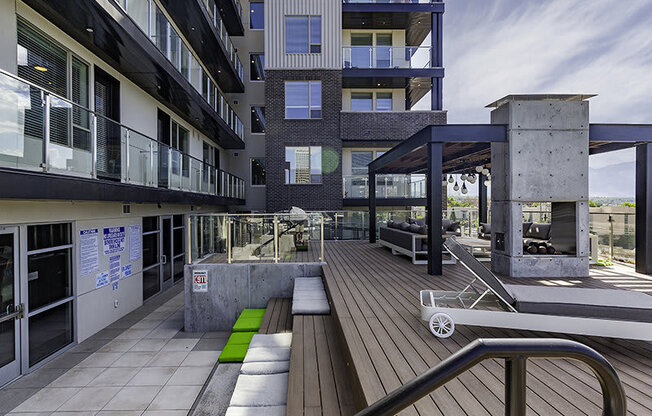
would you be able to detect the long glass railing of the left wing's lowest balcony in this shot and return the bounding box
[0,72,245,199]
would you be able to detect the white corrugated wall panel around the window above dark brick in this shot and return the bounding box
[265,0,342,69]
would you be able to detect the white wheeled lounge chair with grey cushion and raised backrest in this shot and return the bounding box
[420,237,652,341]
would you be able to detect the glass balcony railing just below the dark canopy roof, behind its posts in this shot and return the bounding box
[343,175,426,199]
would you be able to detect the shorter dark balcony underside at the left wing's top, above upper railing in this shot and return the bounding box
[161,0,244,93]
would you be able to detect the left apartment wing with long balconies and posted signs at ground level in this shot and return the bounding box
[0,0,252,385]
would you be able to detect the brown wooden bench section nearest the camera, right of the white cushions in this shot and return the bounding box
[287,315,362,416]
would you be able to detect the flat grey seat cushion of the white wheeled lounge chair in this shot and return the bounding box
[505,285,652,322]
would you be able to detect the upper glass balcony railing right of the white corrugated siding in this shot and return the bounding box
[342,46,432,69]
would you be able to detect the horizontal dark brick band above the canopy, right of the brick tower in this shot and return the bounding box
[340,111,446,145]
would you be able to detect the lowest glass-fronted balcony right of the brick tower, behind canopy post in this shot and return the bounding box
[343,175,426,205]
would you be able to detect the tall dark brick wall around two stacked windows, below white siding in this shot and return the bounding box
[265,70,342,212]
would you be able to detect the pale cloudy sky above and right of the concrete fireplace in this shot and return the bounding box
[415,0,652,197]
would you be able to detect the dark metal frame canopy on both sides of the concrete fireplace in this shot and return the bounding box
[369,120,652,275]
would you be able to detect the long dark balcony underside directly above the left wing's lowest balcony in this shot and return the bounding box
[25,0,244,149]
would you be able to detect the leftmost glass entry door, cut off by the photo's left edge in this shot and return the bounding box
[0,227,23,387]
